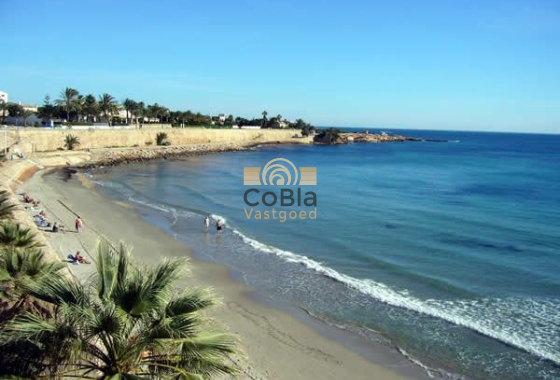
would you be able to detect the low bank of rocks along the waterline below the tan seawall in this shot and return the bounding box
[78,144,250,169]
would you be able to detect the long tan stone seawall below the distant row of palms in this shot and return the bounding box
[7,128,309,154]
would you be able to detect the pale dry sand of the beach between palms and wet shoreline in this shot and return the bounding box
[18,172,425,380]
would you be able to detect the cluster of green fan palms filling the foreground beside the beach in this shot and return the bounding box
[0,191,238,379]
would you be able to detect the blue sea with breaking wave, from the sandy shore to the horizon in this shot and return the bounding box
[88,130,560,380]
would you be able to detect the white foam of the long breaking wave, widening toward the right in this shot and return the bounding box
[233,229,560,364]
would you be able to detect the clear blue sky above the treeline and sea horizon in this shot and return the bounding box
[0,0,560,133]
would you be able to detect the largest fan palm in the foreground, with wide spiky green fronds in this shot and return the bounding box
[0,242,237,380]
